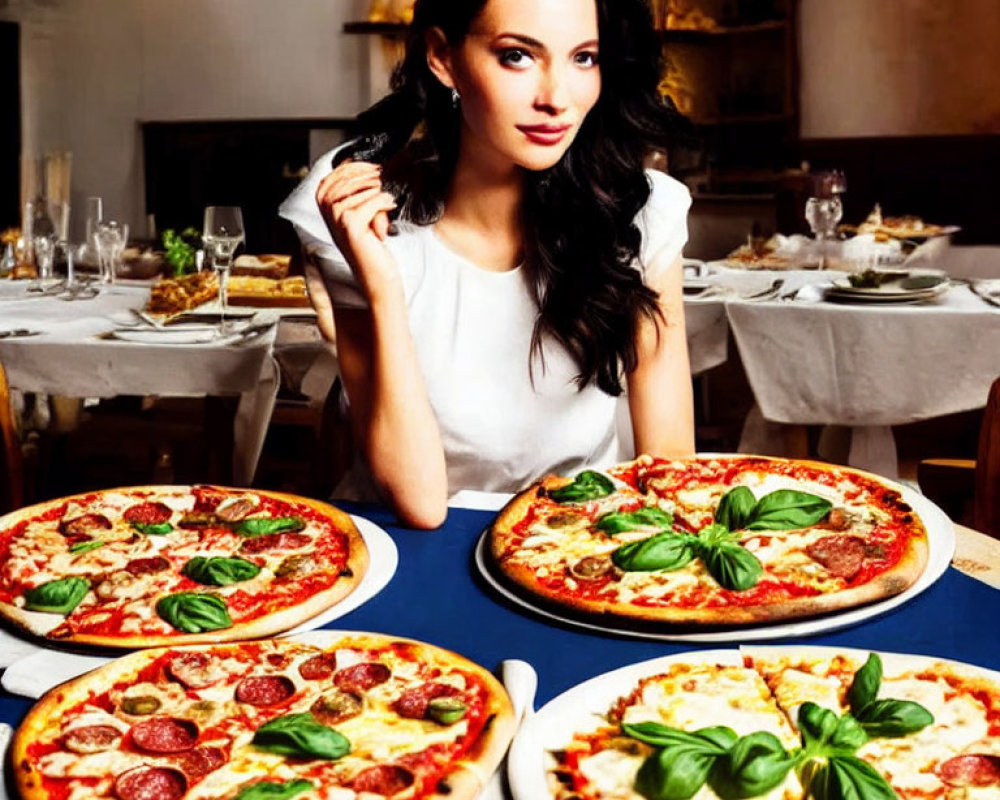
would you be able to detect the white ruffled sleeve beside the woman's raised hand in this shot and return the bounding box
[278,145,368,308]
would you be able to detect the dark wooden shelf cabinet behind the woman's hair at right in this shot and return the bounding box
[656,0,799,197]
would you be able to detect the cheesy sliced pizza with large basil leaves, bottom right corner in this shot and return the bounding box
[540,647,1000,800]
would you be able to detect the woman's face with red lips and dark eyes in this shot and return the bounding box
[449,0,601,170]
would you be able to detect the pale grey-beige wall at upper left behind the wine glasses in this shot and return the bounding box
[0,0,370,236]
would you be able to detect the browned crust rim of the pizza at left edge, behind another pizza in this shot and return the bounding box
[0,486,369,649]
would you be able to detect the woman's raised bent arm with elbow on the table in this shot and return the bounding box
[316,162,448,528]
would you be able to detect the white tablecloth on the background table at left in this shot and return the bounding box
[0,281,279,485]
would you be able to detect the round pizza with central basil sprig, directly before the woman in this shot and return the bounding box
[487,456,928,626]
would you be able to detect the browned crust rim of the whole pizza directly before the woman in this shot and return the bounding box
[487,455,929,631]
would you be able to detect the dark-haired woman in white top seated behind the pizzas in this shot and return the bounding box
[281,0,694,527]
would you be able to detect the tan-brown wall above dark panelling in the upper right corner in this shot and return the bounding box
[799,0,1000,139]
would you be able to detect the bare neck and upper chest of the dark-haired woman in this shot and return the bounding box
[435,141,524,272]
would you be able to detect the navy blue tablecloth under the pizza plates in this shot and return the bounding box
[0,505,1000,725]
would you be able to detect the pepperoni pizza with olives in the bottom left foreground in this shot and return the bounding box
[11,631,514,800]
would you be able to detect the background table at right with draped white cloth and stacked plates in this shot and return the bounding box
[686,265,1000,477]
